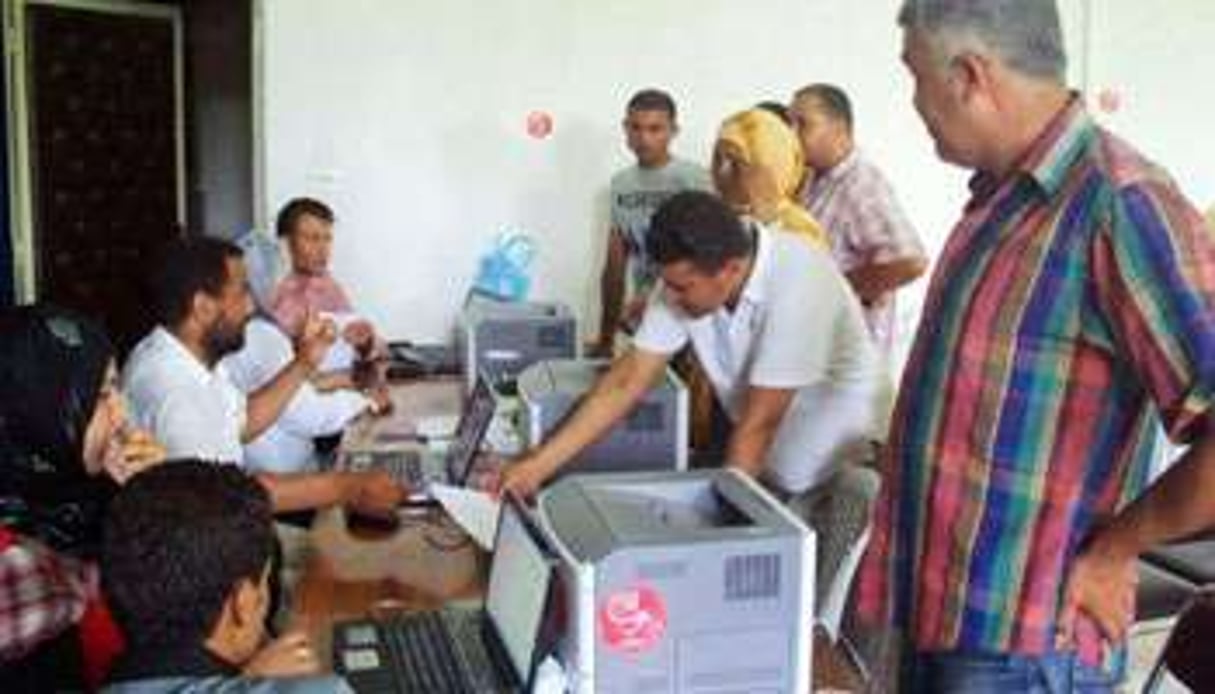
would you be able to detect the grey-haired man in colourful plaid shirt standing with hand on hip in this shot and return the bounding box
[859,0,1215,692]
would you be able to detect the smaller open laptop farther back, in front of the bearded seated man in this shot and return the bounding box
[340,378,497,503]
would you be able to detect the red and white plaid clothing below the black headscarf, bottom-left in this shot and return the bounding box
[0,527,97,662]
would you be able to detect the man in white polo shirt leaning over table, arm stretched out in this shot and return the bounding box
[501,192,878,508]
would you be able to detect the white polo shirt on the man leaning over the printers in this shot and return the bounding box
[633,225,880,493]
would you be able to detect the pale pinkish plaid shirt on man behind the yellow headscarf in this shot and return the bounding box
[802,149,925,351]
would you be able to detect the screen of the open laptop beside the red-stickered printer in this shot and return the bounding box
[486,498,553,682]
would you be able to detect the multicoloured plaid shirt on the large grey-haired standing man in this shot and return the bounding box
[859,98,1215,662]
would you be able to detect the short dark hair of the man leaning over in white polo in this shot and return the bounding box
[645,191,753,273]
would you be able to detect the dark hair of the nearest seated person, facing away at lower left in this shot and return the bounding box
[101,459,275,651]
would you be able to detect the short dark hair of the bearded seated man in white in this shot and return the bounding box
[156,236,244,327]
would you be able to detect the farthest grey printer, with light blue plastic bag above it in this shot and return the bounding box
[456,294,578,391]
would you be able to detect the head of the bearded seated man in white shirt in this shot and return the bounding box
[157,236,253,363]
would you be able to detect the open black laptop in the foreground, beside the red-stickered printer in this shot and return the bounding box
[333,497,556,694]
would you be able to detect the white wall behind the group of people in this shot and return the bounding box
[259,0,1215,347]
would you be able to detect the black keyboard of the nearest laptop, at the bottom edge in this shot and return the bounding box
[384,613,477,694]
